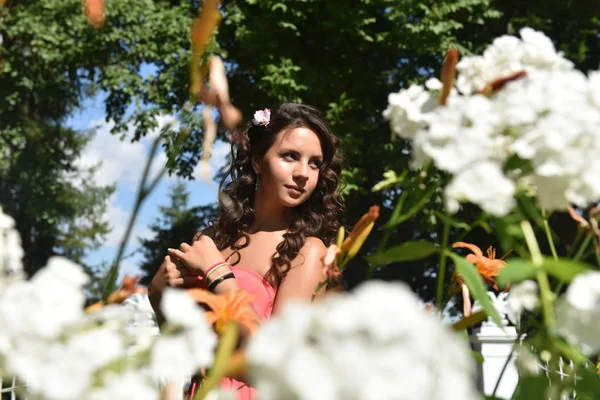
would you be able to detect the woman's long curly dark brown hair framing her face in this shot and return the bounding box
[211,103,344,287]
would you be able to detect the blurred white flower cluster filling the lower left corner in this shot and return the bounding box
[0,208,217,400]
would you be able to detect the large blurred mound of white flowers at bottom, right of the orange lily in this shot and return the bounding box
[248,282,478,400]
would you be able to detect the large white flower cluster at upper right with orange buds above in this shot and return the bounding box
[384,28,600,216]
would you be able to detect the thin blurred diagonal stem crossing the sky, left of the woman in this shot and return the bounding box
[102,137,164,301]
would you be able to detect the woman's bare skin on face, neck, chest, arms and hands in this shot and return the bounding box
[149,128,327,336]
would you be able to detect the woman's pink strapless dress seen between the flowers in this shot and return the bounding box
[185,266,277,400]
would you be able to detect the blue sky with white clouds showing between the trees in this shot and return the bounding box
[67,93,229,277]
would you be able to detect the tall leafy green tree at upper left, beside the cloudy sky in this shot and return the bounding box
[0,0,200,274]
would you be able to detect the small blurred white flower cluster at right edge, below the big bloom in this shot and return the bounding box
[556,271,600,355]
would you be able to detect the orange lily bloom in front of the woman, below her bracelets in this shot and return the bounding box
[186,288,259,334]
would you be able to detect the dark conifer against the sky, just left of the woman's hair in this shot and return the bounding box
[140,182,217,285]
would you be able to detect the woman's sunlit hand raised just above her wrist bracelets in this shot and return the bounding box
[168,235,224,275]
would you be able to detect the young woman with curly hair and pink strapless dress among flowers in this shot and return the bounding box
[150,103,343,399]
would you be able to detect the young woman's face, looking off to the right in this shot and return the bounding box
[258,128,323,207]
